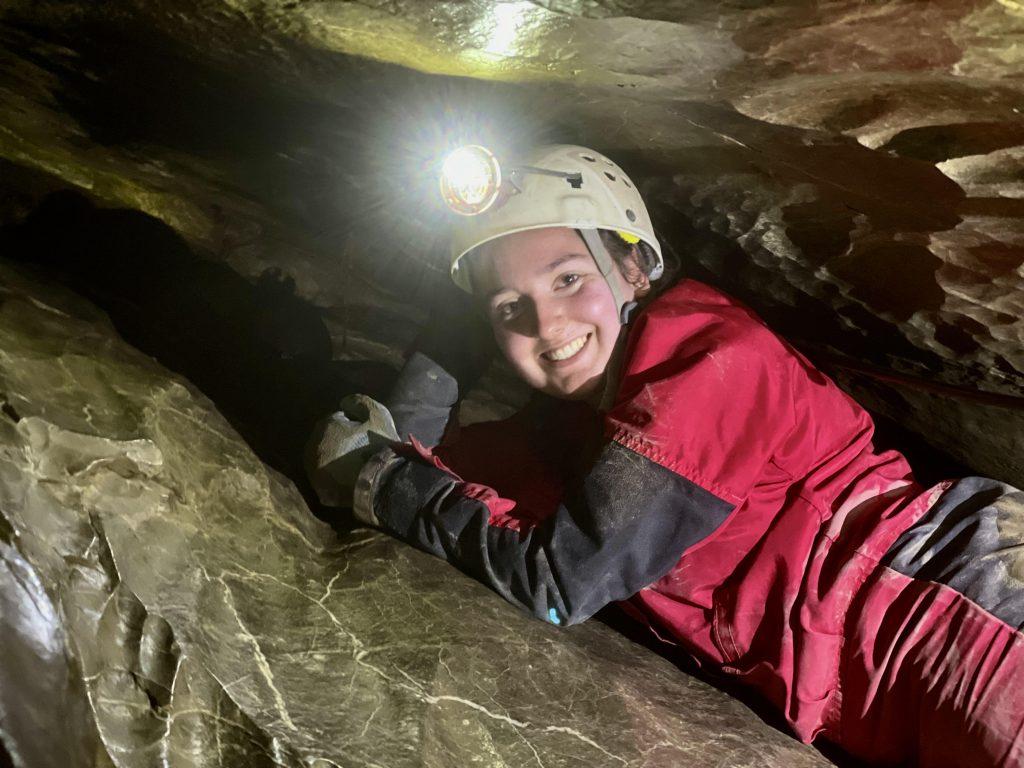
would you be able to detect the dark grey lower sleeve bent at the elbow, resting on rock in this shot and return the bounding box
[372,441,732,625]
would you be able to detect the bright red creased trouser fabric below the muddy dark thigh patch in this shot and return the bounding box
[833,548,1024,768]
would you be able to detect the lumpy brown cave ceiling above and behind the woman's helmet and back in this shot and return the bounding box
[0,0,1024,482]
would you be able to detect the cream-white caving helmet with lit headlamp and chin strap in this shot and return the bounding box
[441,144,665,323]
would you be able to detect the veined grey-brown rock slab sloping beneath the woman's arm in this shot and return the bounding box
[0,265,827,768]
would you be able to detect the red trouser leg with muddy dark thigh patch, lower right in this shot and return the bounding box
[823,477,1024,768]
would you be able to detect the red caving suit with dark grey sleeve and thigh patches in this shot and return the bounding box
[373,281,1024,768]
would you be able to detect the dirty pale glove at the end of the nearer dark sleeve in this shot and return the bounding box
[305,394,398,524]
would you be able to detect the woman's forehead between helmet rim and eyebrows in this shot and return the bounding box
[470,226,590,297]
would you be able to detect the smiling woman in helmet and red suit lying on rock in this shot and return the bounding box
[313,146,1024,766]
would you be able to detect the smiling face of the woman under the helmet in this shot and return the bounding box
[472,227,635,400]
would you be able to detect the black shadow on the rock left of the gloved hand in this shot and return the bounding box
[0,190,395,519]
